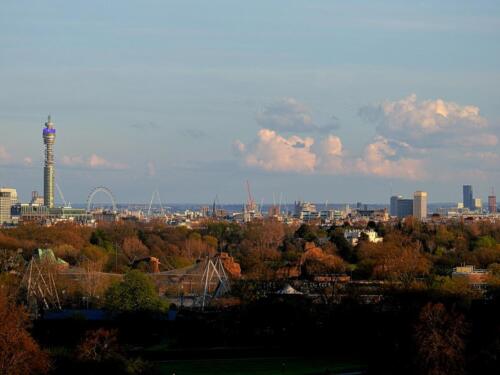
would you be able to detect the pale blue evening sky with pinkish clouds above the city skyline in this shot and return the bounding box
[0,0,500,203]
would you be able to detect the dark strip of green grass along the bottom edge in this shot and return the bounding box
[156,358,364,375]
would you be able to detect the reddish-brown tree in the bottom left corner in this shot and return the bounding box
[0,290,50,375]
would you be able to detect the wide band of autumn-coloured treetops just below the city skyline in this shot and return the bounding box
[0,218,500,284]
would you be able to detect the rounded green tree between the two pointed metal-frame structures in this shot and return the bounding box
[105,270,166,313]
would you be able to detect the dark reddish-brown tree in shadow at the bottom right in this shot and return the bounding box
[415,303,466,375]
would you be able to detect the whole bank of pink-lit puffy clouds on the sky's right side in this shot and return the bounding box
[235,94,500,180]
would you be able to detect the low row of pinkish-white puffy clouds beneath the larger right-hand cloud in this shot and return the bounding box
[235,129,425,180]
